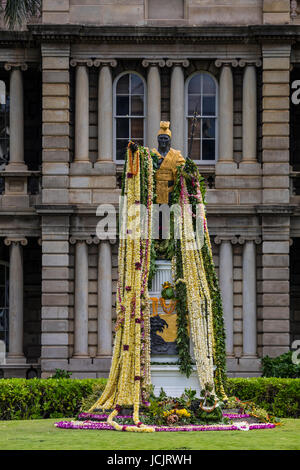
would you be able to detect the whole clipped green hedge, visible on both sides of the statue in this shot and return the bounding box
[0,377,300,420]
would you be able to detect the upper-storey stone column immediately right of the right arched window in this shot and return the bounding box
[215,60,238,163]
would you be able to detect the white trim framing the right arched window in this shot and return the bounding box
[184,70,219,165]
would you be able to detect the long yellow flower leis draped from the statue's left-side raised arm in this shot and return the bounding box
[89,143,155,432]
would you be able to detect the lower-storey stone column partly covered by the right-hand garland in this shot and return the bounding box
[215,237,237,357]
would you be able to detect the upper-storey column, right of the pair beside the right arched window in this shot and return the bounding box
[239,60,261,163]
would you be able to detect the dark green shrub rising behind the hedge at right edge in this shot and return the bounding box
[261,351,300,378]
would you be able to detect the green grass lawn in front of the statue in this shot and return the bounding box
[0,419,300,450]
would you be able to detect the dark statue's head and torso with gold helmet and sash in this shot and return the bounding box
[152,121,185,204]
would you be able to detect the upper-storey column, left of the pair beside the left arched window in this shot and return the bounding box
[70,59,93,168]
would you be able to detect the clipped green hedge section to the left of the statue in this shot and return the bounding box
[0,378,106,420]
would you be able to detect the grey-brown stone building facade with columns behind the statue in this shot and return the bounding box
[0,0,300,378]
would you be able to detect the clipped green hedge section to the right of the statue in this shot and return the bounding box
[227,377,300,418]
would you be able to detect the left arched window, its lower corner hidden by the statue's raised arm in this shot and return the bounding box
[114,72,145,161]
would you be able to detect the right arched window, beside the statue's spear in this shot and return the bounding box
[186,72,218,163]
